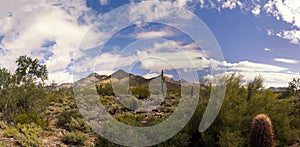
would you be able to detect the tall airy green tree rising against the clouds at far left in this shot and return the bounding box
[1,56,48,124]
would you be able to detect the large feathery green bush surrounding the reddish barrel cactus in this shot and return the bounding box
[199,74,299,146]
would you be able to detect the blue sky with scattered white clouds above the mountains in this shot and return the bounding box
[0,0,300,87]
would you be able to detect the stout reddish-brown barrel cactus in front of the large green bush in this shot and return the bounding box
[250,114,274,147]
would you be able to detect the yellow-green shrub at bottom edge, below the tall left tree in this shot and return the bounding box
[15,123,42,147]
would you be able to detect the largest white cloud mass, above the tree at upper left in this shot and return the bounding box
[0,0,103,84]
